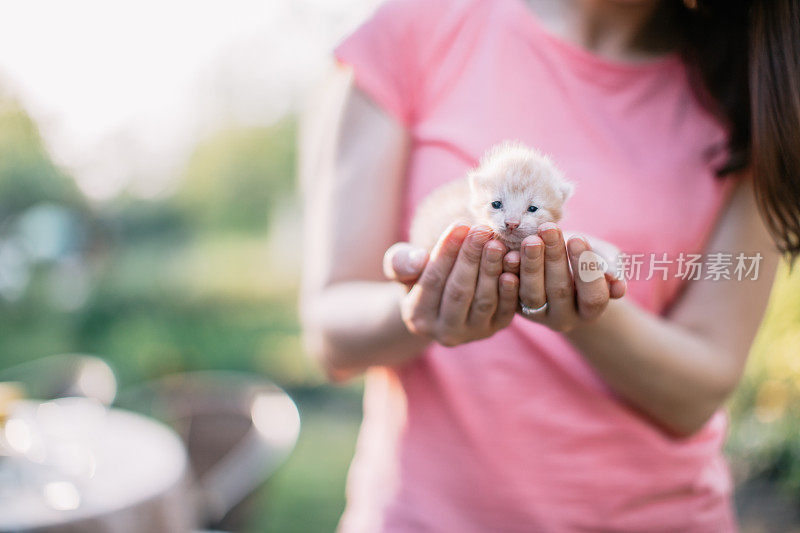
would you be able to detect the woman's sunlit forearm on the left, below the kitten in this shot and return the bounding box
[303,281,430,379]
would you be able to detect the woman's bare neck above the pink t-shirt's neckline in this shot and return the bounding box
[527,0,677,62]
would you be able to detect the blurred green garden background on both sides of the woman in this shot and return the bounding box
[0,79,800,532]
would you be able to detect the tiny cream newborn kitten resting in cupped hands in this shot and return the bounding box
[410,142,573,250]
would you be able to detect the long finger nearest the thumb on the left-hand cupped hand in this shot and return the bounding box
[406,224,469,330]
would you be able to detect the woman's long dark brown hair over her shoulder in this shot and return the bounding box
[672,0,800,260]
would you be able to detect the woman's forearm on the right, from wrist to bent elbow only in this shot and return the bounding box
[566,300,740,436]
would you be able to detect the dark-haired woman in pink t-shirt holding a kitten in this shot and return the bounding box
[303,0,800,532]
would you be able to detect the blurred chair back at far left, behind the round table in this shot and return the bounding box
[0,354,117,405]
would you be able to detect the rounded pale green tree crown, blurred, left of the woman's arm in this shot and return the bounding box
[176,119,296,232]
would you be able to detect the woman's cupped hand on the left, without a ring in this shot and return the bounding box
[384,224,519,346]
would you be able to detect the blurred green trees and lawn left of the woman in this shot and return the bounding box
[0,94,359,531]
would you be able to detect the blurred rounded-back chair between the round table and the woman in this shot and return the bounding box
[119,371,300,531]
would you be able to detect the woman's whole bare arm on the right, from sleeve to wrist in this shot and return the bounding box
[567,180,780,435]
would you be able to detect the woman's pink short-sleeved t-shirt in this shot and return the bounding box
[336,0,735,533]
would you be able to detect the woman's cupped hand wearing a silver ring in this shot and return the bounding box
[519,223,625,332]
